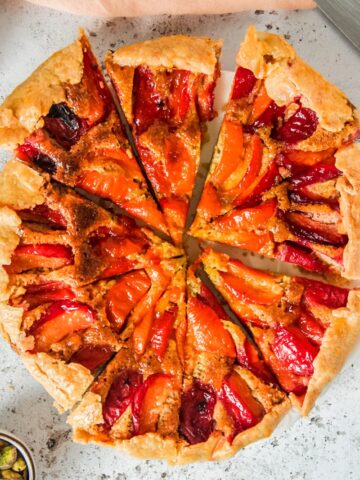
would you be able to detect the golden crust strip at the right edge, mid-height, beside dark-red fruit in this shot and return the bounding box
[335,143,360,279]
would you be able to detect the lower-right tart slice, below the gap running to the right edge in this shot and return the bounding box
[200,249,360,415]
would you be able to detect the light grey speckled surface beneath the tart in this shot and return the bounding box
[0,0,360,480]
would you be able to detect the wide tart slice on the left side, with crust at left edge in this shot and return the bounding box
[0,160,181,411]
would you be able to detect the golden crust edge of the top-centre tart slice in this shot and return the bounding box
[107,35,222,75]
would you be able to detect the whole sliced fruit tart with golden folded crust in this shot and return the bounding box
[0,27,360,464]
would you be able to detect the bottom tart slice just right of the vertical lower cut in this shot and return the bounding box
[178,264,290,463]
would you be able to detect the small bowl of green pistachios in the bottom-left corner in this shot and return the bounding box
[0,431,36,480]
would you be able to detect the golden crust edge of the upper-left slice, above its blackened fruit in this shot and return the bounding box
[0,38,83,149]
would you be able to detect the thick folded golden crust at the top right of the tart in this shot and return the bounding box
[236,26,356,132]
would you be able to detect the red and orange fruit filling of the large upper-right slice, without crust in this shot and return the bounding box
[190,52,349,273]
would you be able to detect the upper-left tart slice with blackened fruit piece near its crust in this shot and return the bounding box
[0,32,167,233]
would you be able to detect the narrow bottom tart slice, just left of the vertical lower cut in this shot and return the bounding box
[68,261,186,462]
